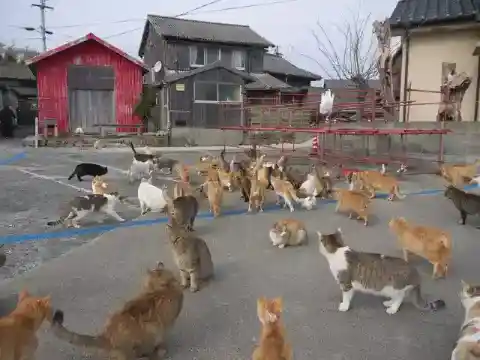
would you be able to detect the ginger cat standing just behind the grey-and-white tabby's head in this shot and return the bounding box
[333,188,371,226]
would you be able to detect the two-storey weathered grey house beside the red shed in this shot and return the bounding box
[138,15,321,129]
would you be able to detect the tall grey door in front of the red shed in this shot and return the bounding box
[68,65,116,132]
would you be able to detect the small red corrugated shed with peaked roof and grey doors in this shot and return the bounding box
[28,33,148,133]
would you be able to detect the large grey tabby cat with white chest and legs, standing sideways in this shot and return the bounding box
[317,228,445,315]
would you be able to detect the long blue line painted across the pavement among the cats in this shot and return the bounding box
[0,185,479,244]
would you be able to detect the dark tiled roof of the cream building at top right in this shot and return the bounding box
[390,0,480,29]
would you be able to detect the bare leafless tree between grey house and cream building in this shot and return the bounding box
[306,11,378,121]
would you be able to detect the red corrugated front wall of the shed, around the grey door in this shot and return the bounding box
[36,40,143,132]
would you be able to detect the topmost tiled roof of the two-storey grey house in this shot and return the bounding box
[147,15,273,47]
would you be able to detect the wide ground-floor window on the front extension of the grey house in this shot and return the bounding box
[194,81,242,103]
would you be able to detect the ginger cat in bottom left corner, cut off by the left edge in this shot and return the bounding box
[0,290,52,360]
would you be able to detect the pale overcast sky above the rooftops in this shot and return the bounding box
[0,0,397,77]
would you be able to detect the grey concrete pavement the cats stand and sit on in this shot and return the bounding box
[0,143,480,360]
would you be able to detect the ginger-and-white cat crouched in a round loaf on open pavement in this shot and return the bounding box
[269,219,308,249]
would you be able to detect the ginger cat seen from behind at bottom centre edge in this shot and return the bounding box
[252,297,293,360]
